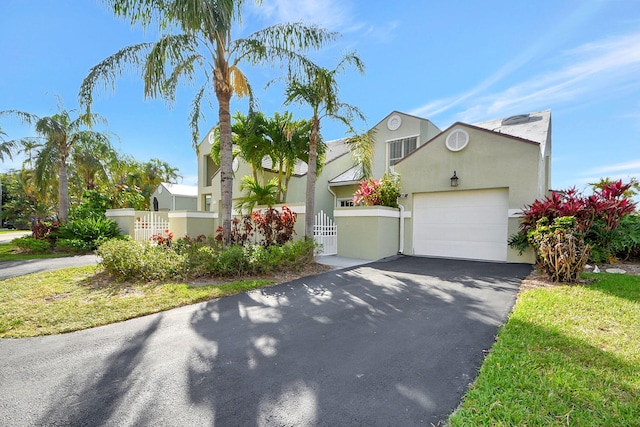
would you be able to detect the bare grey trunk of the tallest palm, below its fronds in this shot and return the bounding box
[217,91,233,244]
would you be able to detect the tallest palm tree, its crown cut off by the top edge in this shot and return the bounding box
[79,0,336,242]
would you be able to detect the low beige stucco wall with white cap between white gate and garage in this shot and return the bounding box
[334,206,400,260]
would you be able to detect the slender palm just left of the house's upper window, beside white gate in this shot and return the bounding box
[285,53,364,239]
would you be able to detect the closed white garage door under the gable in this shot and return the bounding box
[412,189,509,261]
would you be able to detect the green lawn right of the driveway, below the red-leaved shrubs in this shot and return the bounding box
[450,274,640,426]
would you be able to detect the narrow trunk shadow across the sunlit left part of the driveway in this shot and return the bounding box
[37,315,162,426]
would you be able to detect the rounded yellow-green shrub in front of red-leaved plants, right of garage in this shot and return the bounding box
[529,216,591,283]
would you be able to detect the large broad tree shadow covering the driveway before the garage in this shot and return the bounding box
[188,258,530,425]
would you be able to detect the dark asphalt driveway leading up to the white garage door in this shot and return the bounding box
[0,257,531,426]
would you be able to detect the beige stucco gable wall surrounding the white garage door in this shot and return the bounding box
[396,125,543,262]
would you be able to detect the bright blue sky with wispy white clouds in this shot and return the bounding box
[0,0,640,189]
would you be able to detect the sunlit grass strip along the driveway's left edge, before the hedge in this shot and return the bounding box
[0,266,273,338]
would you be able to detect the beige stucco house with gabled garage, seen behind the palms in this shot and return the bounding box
[198,110,551,262]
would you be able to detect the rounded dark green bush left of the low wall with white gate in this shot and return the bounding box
[57,216,120,252]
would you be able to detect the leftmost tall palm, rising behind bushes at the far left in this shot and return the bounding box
[0,105,108,221]
